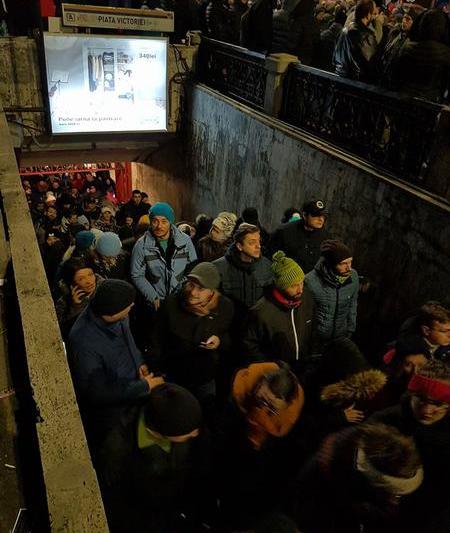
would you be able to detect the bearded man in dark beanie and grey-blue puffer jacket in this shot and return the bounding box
[305,240,359,353]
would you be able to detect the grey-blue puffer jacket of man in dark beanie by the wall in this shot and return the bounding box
[305,257,359,343]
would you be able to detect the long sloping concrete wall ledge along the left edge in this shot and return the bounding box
[0,106,109,533]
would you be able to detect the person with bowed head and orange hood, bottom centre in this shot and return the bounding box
[216,363,304,531]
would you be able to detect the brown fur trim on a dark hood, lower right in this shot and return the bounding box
[320,370,387,407]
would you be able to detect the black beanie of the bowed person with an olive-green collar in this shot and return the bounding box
[144,383,202,437]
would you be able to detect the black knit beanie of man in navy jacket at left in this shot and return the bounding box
[90,279,136,316]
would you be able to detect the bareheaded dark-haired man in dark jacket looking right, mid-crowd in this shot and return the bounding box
[214,223,272,318]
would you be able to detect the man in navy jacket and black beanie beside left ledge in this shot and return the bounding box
[69,279,164,442]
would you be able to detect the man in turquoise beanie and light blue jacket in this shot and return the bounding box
[131,202,197,311]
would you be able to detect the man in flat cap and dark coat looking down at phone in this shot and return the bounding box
[150,263,234,413]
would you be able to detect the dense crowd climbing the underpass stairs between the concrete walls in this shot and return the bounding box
[22,167,450,533]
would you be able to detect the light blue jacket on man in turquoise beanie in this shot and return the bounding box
[131,226,197,304]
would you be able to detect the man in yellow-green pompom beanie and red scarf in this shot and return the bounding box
[244,251,314,367]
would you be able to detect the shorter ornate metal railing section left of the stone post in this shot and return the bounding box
[197,37,267,110]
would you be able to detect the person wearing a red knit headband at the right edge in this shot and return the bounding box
[370,360,450,533]
